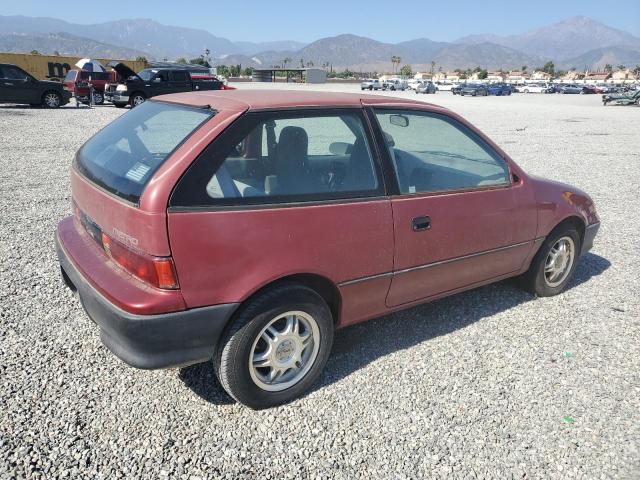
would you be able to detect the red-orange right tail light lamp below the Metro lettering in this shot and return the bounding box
[102,232,179,290]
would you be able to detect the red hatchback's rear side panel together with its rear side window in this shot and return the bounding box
[168,108,393,321]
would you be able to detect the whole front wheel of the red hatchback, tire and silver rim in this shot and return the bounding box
[520,227,581,297]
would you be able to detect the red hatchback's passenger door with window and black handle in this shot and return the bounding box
[373,108,537,307]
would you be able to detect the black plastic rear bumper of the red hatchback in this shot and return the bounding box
[56,234,239,369]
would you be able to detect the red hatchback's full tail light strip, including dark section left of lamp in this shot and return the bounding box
[72,202,180,290]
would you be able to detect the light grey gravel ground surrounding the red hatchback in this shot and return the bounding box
[0,85,640,479]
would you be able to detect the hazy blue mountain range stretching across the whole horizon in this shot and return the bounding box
[0,15,640,71]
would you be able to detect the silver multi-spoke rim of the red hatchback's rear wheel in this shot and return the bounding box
[249,311,320,392]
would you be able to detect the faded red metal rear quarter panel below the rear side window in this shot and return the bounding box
[168,199,393,313]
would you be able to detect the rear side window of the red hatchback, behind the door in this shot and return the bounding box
[171,110,383,207]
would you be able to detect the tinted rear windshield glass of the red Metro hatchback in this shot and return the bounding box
[76,101,214,203]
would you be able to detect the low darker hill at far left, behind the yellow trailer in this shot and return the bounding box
[0,33,146,60]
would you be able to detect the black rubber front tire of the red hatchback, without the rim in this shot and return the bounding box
[518,224,581,297]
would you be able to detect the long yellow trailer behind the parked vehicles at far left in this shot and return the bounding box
[0,52,147,82]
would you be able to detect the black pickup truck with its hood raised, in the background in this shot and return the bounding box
[104,63,232,108]
